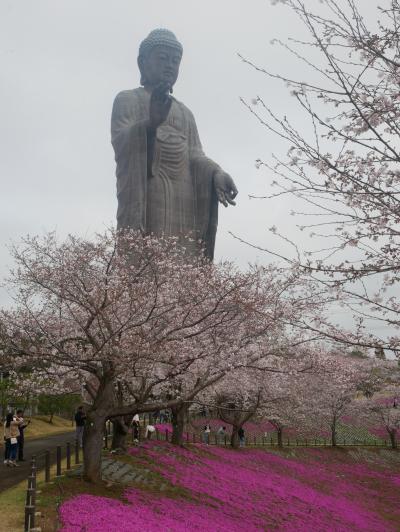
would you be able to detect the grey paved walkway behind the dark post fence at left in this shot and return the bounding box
[0,432,75,492]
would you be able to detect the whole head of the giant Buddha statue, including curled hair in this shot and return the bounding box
[138,29,183,92]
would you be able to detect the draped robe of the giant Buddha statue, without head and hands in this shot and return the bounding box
[111,87,220,259]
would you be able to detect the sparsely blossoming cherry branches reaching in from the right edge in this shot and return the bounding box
[243,0,400,358]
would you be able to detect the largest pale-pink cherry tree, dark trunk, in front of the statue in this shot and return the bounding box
[0,231,317,482]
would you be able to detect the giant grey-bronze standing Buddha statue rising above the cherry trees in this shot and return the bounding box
[111,29,237,260]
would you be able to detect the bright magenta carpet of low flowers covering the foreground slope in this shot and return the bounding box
[60,442,400,532]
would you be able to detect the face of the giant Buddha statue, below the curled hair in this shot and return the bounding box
[138,45,182,90]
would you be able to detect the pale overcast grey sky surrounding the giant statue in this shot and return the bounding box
[0,0,388,338]
